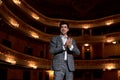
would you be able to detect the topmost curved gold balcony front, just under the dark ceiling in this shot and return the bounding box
[3,0,120,28]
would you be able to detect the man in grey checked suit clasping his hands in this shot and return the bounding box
[50,22,80,80]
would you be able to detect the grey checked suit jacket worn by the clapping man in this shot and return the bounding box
[49,36,80,71]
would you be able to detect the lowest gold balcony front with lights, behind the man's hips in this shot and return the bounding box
[0,44,120,70]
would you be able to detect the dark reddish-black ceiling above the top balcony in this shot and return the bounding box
[25,0,120,20]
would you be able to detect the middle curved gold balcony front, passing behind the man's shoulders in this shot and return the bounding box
[0,3,120,43]
